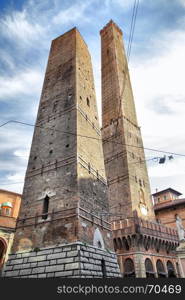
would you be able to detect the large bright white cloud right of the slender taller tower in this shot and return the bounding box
[130,31,185,194]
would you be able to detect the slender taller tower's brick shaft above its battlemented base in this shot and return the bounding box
[100,21,154,219]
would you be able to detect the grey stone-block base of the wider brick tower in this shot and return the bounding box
[2,242,121,278]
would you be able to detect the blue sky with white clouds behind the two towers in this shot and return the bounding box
[0,0,185,196]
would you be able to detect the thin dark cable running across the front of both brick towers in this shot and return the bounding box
[0,120,185,157]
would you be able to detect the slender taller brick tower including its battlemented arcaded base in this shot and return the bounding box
[100,21,178,277]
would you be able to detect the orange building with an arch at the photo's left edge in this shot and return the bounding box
[0,190,21,270]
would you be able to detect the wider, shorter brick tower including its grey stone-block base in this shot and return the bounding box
[4,28,119,277]
